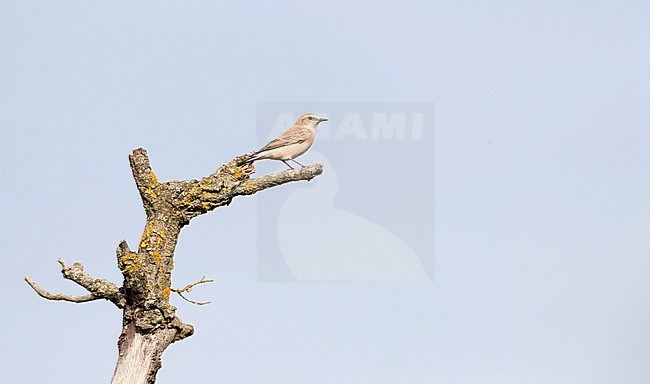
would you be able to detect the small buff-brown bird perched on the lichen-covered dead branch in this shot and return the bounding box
[244,113,328,169]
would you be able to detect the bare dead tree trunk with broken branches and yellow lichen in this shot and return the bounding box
[25,148,323,384]
